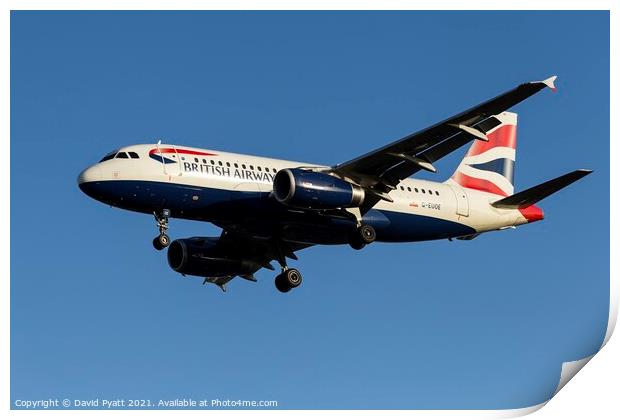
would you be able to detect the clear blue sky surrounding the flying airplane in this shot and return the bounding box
[11,12,609,408]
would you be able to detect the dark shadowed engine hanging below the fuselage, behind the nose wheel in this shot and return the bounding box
[168,237,260,277]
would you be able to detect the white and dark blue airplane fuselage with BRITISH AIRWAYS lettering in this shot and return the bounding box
[78,144,542,244]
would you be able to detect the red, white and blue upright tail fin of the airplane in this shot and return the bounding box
[451,112,517,197]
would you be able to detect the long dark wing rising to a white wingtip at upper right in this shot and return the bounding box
[329,76,556,202]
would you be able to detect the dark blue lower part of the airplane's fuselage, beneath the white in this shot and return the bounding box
[80,180,476,243]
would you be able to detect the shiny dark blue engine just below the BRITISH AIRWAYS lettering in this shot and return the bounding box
[273,168,364,209]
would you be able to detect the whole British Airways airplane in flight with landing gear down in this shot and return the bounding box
[78,76,592,293]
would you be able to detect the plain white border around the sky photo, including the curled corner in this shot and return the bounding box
[0,0,620,419]
